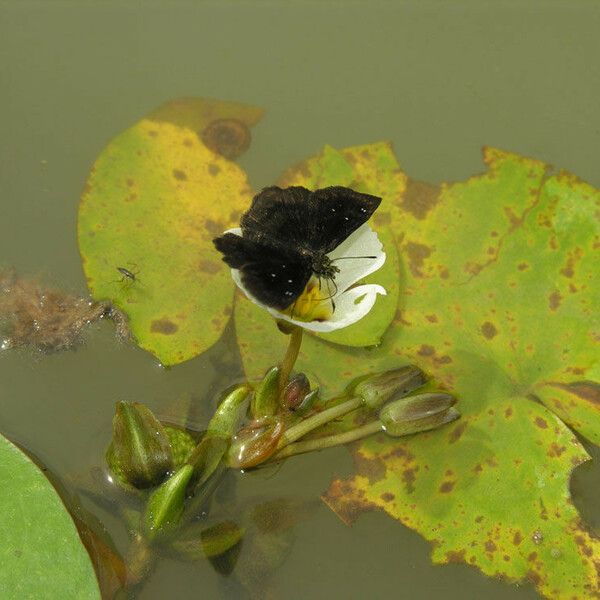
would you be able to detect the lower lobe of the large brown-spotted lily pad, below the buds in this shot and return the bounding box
[323,398,600,599]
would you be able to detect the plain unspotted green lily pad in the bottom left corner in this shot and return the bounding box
[0,436,100,600]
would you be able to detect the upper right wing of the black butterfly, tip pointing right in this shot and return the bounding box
[307,186,381,254]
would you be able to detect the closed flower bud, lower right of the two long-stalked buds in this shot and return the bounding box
[379,393,460,437]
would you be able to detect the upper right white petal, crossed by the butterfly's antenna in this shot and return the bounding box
[328,223,385,291]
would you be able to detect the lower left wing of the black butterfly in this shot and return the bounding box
[214,233,312,310]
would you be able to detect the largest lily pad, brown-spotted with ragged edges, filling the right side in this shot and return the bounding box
[236,143,600,598]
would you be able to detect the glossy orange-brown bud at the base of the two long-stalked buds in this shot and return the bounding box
[228,419,285,469]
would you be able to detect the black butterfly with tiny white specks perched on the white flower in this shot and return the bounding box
[213,186,381,310]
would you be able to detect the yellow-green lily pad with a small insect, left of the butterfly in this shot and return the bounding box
[78,99,260,365]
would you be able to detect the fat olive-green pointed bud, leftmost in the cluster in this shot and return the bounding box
[106,401,173,489]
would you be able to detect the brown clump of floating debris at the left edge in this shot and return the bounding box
[0,269,130,352]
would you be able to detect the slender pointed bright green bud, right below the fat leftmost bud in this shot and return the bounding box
[144,465,194,539]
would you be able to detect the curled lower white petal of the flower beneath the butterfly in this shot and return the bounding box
[268,283,386,333]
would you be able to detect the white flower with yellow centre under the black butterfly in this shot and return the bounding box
[227,223,386,333]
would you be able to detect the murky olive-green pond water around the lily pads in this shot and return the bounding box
[0,0,600,599]
